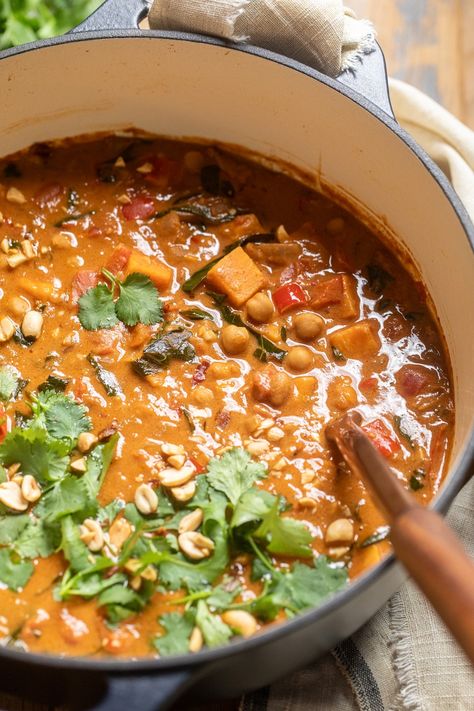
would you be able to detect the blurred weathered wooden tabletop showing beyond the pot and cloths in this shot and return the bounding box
[0,0,474,711]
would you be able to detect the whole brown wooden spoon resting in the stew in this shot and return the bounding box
[326,411,474,664]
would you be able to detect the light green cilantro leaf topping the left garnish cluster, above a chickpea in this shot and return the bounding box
[32,390,92,446]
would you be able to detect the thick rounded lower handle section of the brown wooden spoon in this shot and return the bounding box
[390,506,474,664]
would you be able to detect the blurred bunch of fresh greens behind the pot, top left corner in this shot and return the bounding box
[0,0,101,50]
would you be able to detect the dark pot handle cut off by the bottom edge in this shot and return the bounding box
[87,669,196,711]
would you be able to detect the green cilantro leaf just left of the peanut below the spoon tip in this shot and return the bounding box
[253,499,313,558]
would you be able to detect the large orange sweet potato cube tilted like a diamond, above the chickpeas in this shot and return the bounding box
[207,247,266,306]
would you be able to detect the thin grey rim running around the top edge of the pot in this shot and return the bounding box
[0,29,474,674]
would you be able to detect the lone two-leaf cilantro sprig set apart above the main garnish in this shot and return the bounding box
[78,269,163,331]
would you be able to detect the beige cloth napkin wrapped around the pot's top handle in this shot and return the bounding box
[148,0,374,76]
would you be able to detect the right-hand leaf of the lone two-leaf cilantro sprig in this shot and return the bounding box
[115,272,163,326]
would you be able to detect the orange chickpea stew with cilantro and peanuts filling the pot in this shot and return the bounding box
[0,135,453,656]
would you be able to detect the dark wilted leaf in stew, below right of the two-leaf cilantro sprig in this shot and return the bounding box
[132,329,196,376]
